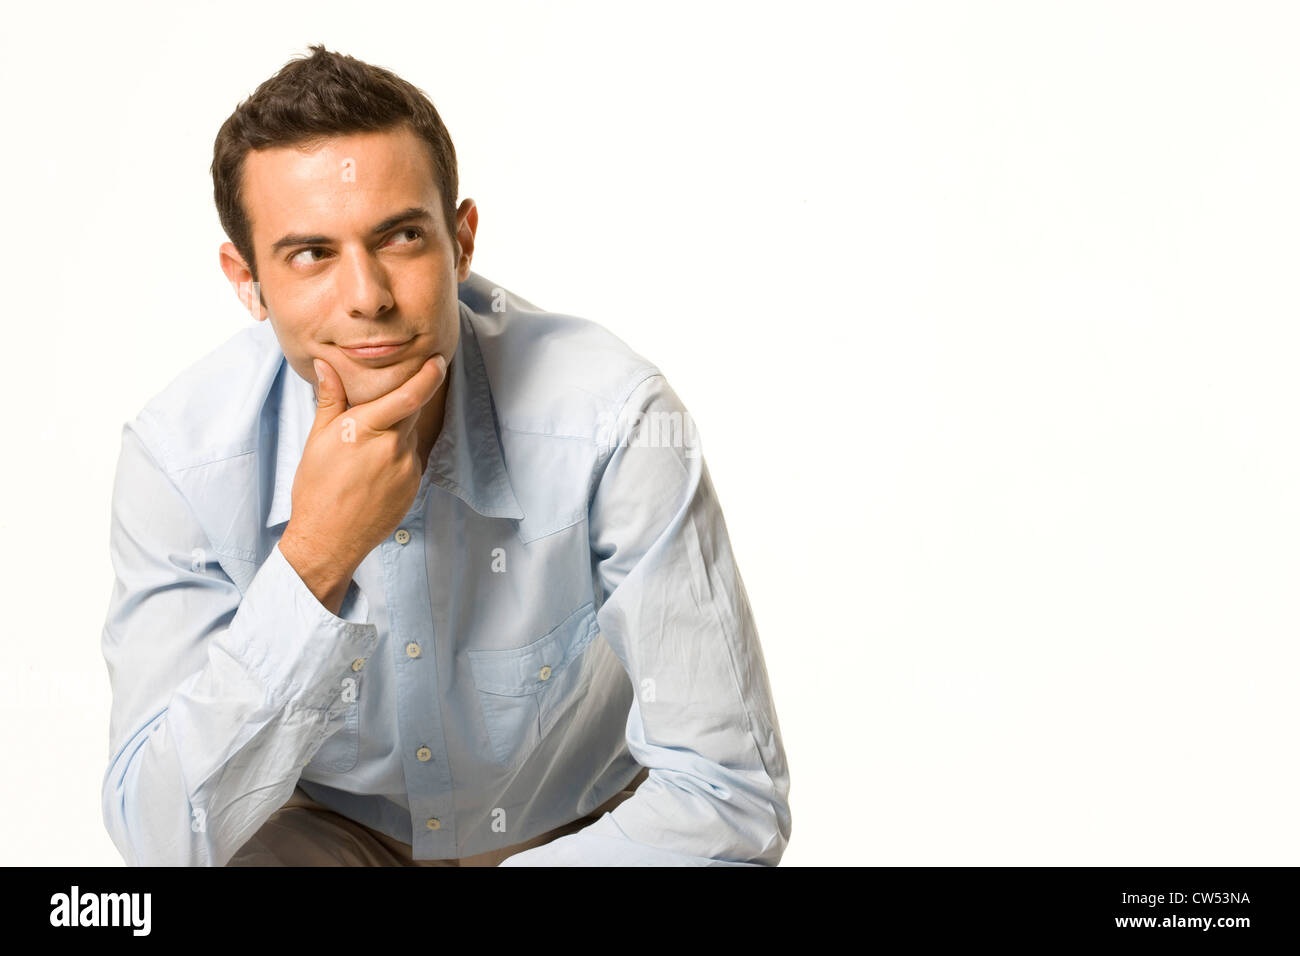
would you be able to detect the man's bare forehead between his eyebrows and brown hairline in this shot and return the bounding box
[242,126,441,246]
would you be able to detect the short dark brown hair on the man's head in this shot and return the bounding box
[212,44,458,280]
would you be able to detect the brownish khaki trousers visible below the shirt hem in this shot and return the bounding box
[226,767,650,866]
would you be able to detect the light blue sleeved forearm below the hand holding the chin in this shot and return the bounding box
[103,549,378,866]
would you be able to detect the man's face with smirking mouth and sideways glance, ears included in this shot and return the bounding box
[221,127,478,405]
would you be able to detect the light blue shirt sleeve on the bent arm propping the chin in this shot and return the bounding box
[101,424,378,866]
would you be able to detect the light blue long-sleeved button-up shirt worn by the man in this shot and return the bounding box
[103,274,790,865]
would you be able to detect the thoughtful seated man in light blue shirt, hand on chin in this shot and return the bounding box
[103,47,790,865]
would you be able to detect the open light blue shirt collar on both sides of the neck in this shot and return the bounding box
[267,302,524,528]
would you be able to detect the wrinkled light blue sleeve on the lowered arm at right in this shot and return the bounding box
[502,373,790,866]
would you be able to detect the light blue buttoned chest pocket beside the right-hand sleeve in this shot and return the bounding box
[467,601,598,767]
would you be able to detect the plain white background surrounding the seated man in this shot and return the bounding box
[0,0,1300,865]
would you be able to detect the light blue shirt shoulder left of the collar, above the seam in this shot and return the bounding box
[129,321,285,473]
